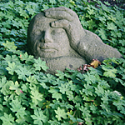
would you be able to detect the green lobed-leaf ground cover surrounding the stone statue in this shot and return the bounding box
[0,0,125,125]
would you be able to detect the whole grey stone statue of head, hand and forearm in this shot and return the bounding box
[27,7,121,74]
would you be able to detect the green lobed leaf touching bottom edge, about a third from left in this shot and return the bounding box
[31,108,47,125]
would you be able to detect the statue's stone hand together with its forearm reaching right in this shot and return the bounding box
[44,7,121,62]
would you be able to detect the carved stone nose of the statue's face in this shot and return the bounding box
[42,30,53,43]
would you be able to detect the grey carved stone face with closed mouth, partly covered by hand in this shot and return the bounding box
[28,13,71,58]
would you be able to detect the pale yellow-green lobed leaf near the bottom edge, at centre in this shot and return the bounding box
[55,107,67,121]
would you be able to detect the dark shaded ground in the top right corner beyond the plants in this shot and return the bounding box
[88,0,125,9]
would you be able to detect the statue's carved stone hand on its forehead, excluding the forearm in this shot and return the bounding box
[44,7,85,50]
